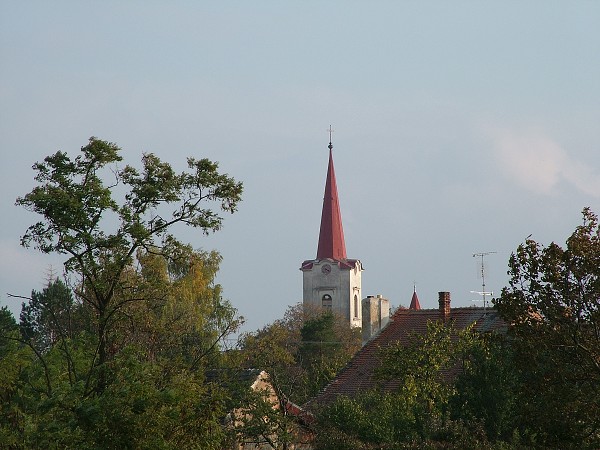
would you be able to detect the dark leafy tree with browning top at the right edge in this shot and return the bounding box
[496,208,600,448]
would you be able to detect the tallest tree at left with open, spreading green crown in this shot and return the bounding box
[16,138,242,391]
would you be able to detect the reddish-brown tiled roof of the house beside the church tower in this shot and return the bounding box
[306,307,506,409]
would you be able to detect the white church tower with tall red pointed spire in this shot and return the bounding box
[300,134,363,327]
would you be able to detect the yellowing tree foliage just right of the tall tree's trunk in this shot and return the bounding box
[109,246,243,370]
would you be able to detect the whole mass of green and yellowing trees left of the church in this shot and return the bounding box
[0,138,242,449]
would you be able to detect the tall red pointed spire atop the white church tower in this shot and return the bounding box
[317,140,346,260]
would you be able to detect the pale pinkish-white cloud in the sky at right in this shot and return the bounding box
[492,130,600,197]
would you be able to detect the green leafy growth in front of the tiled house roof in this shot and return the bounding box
[315,322,514,449]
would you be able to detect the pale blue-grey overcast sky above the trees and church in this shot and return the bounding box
[0,0,600,330]
